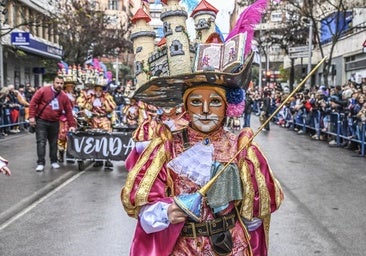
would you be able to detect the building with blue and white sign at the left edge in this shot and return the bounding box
[0,0,62,87]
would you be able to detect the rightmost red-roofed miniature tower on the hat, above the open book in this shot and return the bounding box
[191,0,219,43]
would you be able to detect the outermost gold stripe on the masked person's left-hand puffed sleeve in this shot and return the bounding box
[121,138,162,218]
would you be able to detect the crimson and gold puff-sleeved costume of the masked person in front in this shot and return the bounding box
[121,126,283,255]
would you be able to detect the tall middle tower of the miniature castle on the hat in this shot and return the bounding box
[160,0,192,76]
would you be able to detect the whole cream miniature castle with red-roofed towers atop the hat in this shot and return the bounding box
[130,0,222,89]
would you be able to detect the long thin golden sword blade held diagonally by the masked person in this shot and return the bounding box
[198,57,327,196]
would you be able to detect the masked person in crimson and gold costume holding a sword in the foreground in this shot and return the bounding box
[121,57,283,255]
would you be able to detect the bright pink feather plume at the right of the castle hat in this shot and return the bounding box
[225,0,268,55]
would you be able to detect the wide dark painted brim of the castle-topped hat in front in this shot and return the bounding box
[133,52,254,107]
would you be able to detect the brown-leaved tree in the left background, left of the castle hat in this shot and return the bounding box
[54,0,132,64]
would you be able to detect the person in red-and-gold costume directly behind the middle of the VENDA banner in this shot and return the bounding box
[78,80,116,169]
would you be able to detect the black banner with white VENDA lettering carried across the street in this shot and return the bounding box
[67,131,135,161]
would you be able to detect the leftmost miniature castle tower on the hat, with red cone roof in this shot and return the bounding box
[130,8,156,88]
